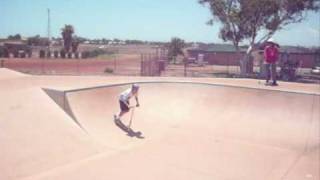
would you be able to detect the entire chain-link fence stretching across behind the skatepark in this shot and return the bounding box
[0,51,318,83]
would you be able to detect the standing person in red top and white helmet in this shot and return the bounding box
[264,38,279,86]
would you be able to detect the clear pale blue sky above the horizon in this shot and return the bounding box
[0,0,320,47]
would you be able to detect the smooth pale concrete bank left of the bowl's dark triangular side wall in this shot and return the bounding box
[0,88,100,180]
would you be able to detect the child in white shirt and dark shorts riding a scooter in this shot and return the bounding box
[114,84,140,122]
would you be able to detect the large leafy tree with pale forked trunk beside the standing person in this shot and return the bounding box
[199,0,320,75]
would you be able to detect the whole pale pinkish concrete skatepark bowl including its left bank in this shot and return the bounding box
[0,68,320,180]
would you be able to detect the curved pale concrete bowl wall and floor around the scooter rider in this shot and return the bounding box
[37,83,320,180]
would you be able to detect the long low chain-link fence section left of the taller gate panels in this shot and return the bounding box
[0,58,140,76]
